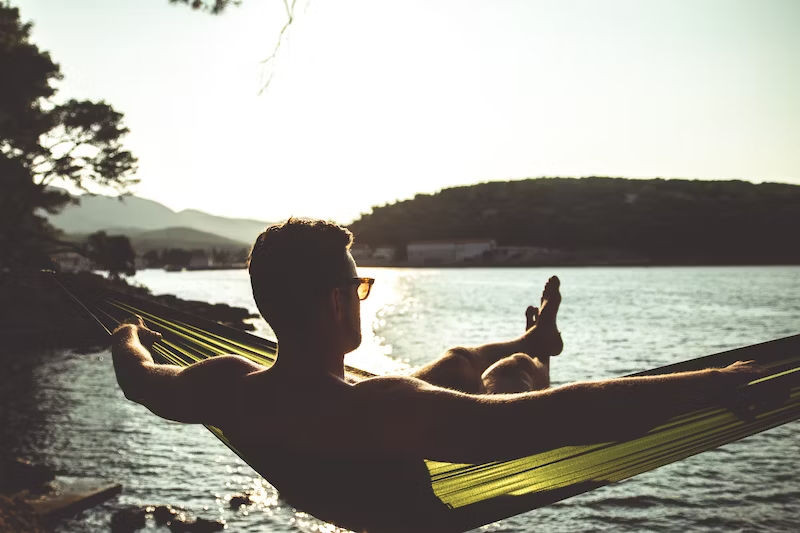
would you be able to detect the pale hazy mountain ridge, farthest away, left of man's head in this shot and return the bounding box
[49,195,270,246]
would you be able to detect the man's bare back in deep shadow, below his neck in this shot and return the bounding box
[220,370,446,531]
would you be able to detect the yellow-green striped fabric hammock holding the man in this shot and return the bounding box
[54,278,800,531]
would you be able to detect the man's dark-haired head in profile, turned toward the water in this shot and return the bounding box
[248,218,361,352]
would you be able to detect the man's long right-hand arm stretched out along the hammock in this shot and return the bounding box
[338,363,760,463]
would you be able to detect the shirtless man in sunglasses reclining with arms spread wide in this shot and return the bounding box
[112,219,758,532]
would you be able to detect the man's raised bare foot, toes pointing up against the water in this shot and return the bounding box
[524,276,564,357]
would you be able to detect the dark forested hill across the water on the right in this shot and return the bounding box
[350,177,800,263]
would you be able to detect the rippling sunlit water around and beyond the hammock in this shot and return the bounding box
[0,267,800,533]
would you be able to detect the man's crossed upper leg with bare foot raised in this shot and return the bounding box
[412,276,563,394]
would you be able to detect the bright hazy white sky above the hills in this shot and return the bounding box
[12,0,800,222]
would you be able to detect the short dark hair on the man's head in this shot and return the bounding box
[247,218,353,332]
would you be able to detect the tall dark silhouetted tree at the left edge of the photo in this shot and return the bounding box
[0,1,138,268]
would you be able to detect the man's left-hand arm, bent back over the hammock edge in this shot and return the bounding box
[111,319,263,426]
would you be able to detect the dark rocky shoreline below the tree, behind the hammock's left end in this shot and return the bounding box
[0,272,256,355]
